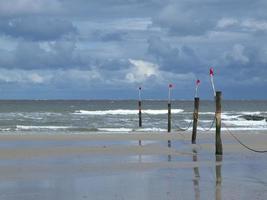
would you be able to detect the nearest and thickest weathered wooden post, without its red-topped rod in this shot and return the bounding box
[215,91,223,155]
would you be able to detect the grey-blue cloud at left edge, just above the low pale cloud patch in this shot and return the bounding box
[0,41,85,70]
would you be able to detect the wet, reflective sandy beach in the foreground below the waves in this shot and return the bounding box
[0,132,267,200]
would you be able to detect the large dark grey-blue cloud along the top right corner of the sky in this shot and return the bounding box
[154,0,267,36]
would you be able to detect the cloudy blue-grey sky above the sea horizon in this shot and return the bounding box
[0,0,267,100]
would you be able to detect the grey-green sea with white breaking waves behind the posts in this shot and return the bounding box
[0,100,267,135]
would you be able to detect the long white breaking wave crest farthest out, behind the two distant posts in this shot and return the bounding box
[74,109,183,115]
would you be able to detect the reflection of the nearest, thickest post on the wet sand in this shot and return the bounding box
[215,155,223,200]
